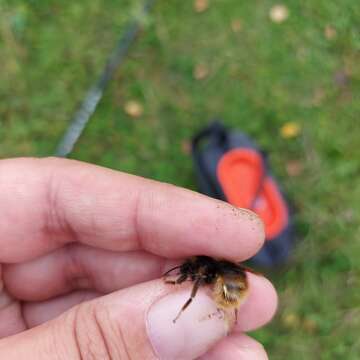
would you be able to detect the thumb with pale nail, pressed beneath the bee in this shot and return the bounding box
[0,280,228,360]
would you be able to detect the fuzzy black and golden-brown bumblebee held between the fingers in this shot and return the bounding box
[164,256,253,323]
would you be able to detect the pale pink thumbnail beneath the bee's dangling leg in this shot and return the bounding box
[147,291,229,360]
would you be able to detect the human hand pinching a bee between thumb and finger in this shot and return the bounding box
[0,159,277,360]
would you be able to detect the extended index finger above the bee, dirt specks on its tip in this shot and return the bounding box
[0,158,264,262]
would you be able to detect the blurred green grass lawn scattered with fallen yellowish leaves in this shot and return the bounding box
[0,0,360,360]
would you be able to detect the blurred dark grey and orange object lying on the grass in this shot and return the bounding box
[192,121,293,268]
